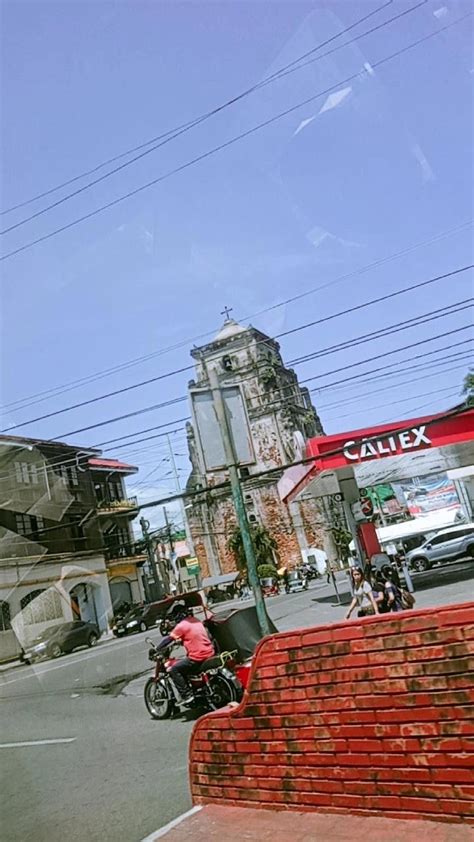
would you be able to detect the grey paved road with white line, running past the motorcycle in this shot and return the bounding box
[0,562,473,842]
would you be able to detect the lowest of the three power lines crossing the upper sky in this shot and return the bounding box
[0,12,466,260]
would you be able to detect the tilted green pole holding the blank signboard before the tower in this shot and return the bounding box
[209,368,270,635]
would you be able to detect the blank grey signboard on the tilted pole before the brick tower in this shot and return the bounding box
[190,386,255,471]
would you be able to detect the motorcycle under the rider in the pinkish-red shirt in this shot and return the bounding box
[144,638,243,719]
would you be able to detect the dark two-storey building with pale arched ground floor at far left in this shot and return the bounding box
[0,436,141,661]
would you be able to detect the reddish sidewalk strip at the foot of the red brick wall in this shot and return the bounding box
[151,805,474,842]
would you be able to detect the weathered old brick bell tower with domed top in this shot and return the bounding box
[187,319,323,576]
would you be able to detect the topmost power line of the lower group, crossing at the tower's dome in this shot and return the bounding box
[3,219,473,409]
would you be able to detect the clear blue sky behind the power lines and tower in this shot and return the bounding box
[0,0,474,524]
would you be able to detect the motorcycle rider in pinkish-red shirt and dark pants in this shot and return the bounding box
[157,605,215,704]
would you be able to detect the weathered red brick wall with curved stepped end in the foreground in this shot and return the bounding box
[190,603,474,821]
